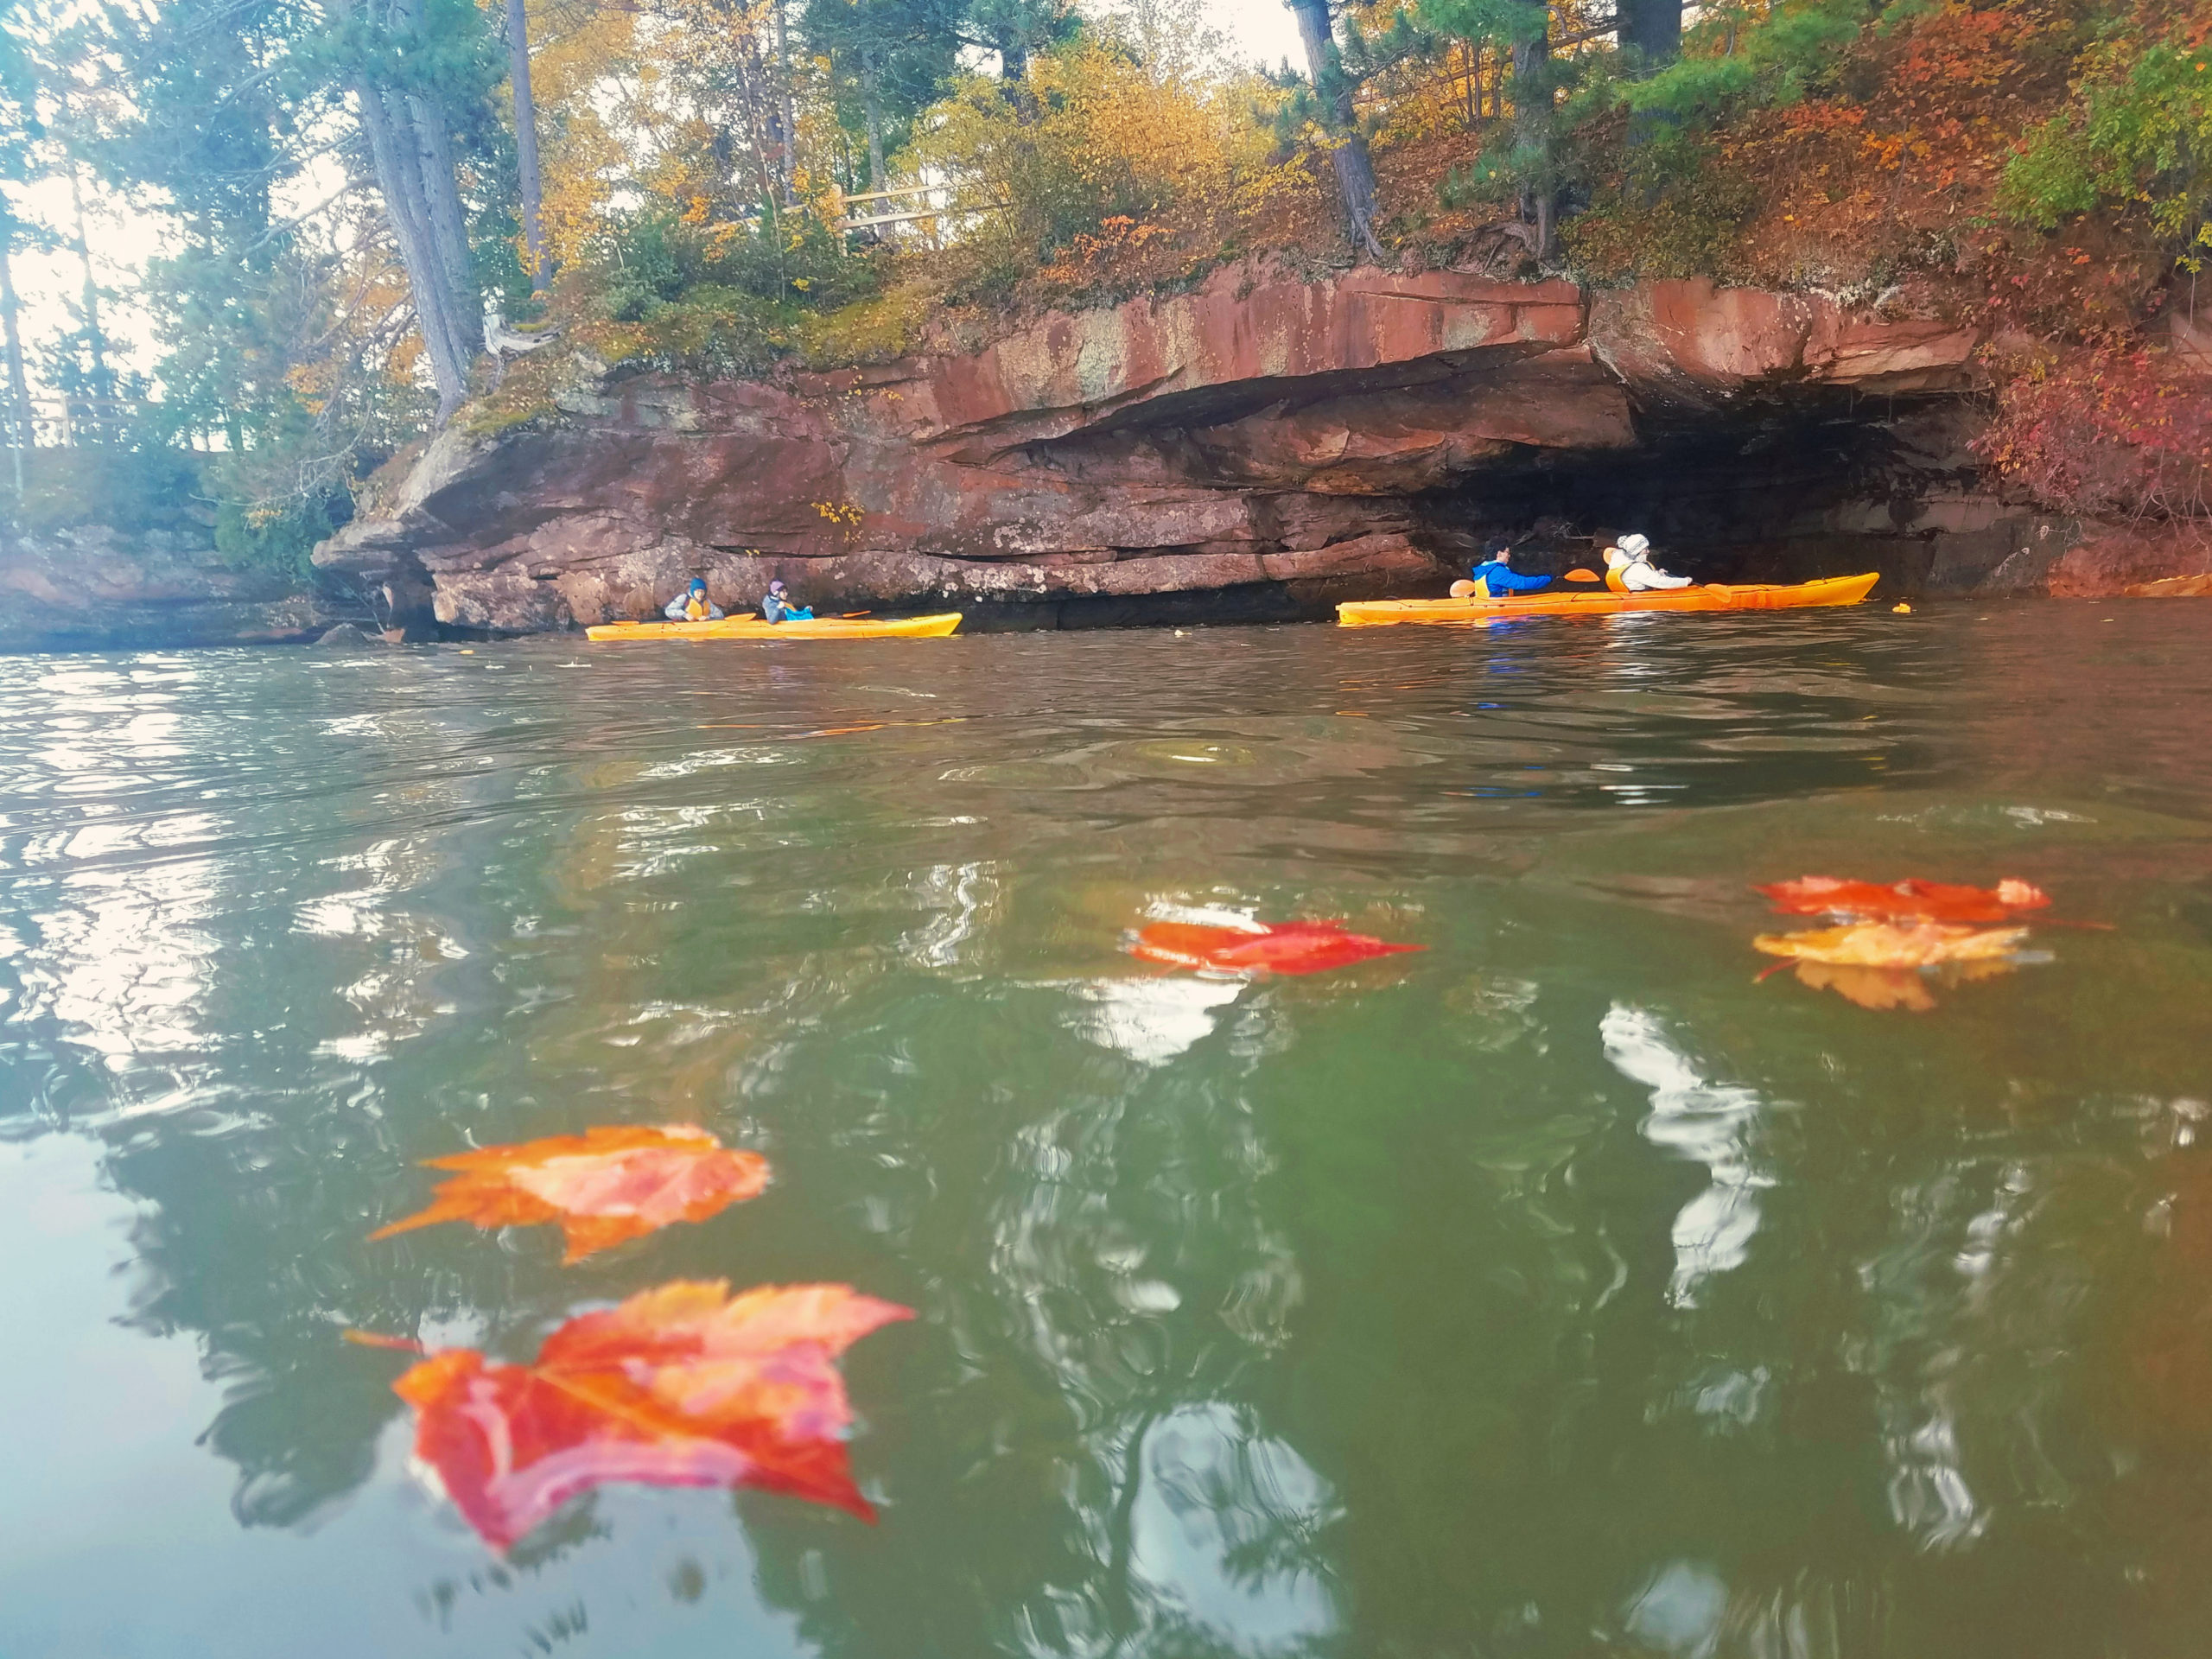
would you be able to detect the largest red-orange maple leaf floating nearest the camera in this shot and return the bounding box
[389,1281,913,1553]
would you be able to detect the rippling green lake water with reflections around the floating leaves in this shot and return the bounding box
[0,601,2212,1659]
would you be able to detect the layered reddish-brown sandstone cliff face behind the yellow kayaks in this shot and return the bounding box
[316,270,2025,632]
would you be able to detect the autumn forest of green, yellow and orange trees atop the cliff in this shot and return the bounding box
[0,0,2212,569]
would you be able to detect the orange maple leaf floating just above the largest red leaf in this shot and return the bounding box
[370,1126,767,1261]
